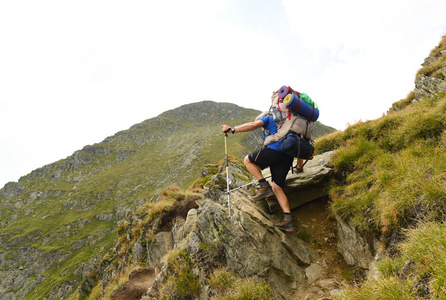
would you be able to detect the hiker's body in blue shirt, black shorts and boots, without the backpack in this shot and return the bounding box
[221,93,296,231]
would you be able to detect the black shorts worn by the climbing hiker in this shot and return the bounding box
[248,148,293,188]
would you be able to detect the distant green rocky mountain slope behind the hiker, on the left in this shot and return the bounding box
[0,101,336,299]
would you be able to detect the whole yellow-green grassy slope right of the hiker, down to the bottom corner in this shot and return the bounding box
[317,37,446,299]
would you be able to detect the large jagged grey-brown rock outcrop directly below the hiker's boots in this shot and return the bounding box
[146,190,319,299]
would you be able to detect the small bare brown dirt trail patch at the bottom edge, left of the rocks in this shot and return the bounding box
[111,268,155,300]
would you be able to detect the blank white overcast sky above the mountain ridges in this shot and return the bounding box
[0,0,446,188]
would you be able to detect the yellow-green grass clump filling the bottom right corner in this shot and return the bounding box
[336,222,446,300]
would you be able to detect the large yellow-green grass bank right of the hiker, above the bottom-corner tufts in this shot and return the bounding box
[322,96,446,233]
